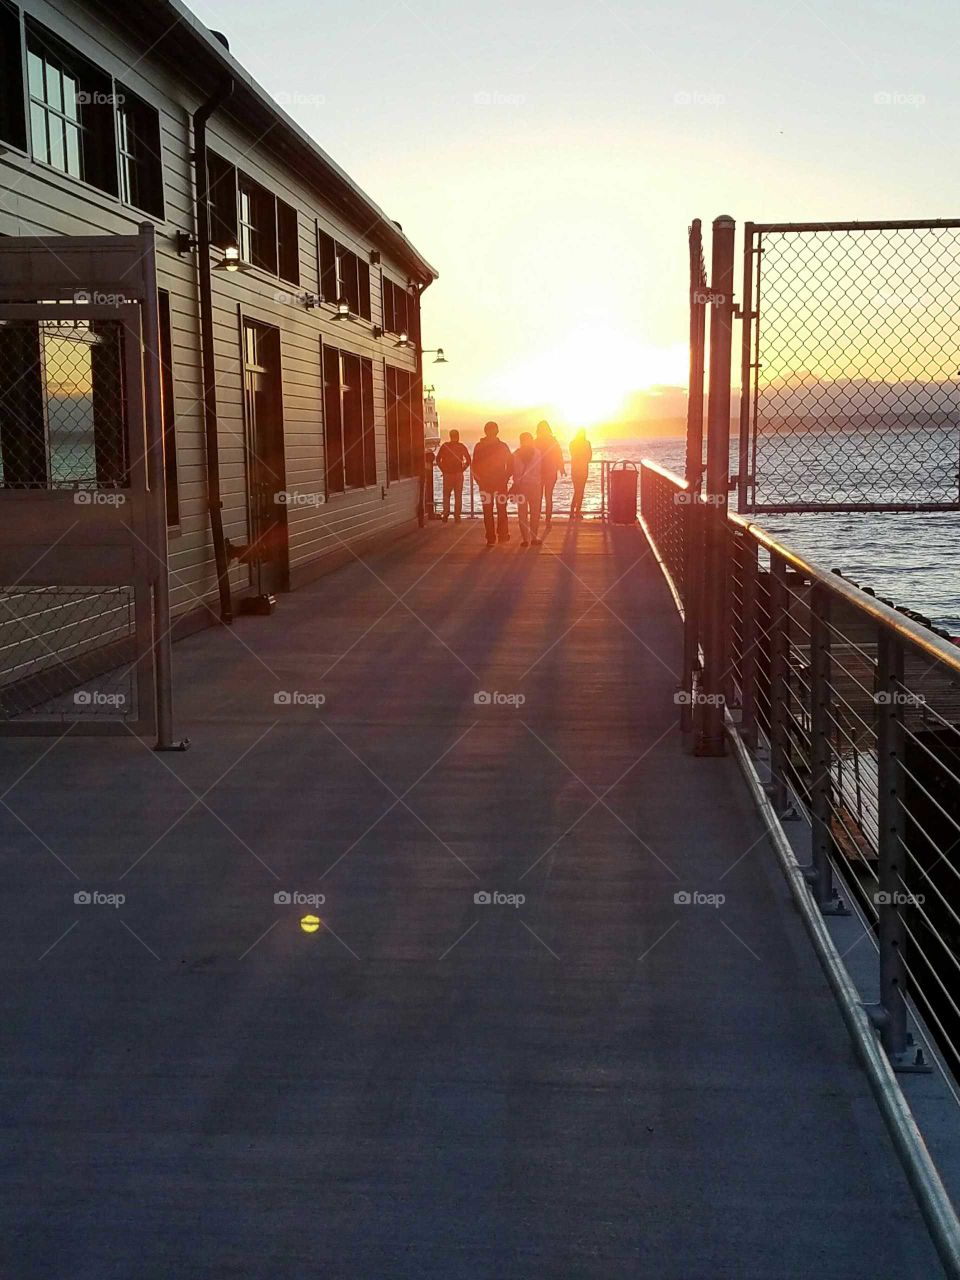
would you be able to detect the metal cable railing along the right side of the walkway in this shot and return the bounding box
[640,462,960,1078]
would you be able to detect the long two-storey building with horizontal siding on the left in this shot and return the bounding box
[0,0,436,645]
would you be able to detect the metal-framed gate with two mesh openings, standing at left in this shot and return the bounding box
[0,227,173,748]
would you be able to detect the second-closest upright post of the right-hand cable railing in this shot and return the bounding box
[808,582,850,915]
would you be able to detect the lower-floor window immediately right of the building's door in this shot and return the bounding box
[323,346,376,493]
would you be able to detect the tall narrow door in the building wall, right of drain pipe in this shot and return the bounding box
[243,320,289,595]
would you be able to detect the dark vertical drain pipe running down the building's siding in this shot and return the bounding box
[193,79,233,626]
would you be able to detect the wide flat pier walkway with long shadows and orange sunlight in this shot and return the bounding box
[0,522,937,1280]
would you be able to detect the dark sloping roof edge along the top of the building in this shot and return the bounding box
[152,0,438,284]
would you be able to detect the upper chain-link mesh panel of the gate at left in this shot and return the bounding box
[0,319,128,492]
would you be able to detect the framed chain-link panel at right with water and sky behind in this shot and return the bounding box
[736,220,960,512]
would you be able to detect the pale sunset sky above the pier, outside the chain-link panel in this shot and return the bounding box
[192,0,960,438]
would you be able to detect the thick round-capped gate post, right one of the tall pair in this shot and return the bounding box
[696,215,736,755]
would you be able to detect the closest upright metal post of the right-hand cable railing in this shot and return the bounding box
[876,627,909,1060]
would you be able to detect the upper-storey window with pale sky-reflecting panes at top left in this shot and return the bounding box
[27,23,118,196]
